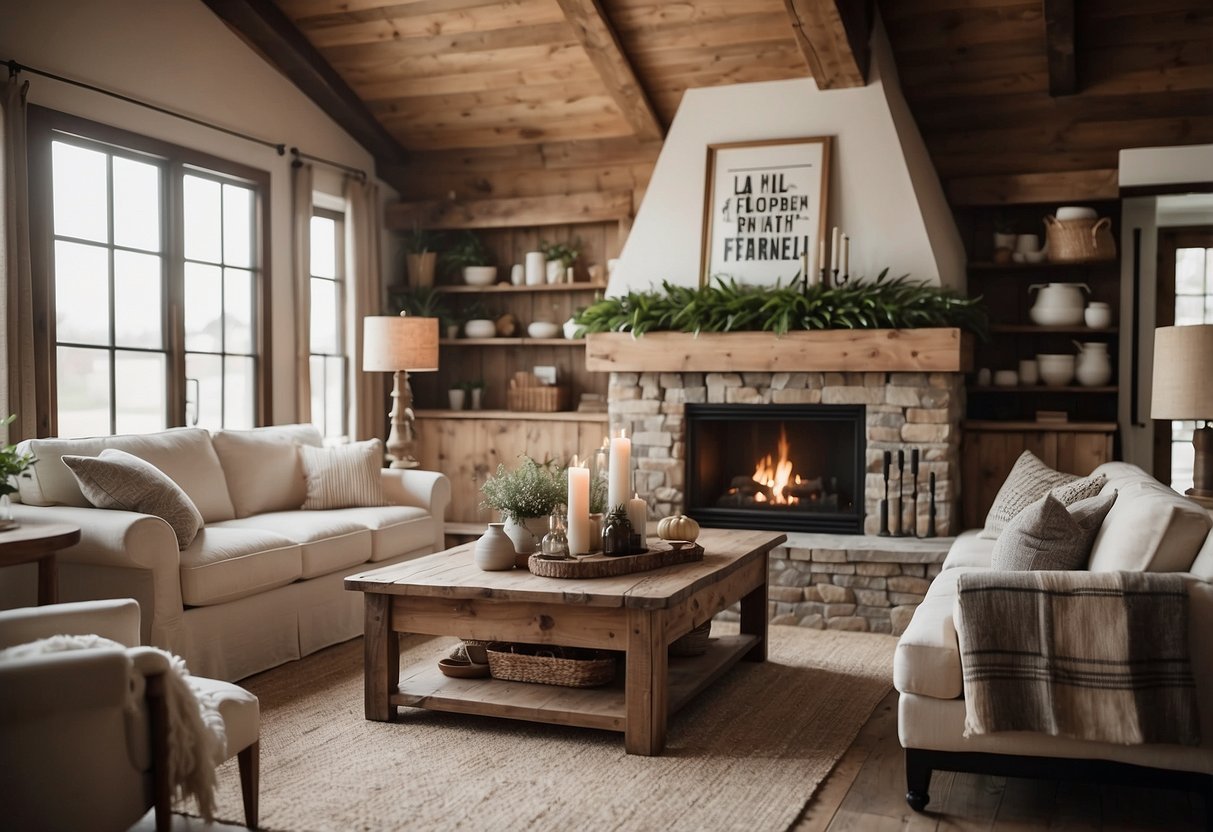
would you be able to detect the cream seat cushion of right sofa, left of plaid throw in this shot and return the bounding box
[893,566,986,699]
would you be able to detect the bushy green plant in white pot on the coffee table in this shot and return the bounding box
[480,456,568,564]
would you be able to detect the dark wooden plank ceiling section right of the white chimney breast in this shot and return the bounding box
[878,0,1213,205]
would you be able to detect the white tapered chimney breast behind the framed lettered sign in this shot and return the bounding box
[608,19,964,295]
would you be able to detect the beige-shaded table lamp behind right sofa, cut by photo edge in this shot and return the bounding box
[1150,324,1213,497]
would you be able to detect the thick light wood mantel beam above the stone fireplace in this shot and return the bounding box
[586,327,973,372]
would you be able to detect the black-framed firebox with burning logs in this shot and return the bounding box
[685,404,866,535]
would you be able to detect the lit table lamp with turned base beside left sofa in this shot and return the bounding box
[363,312,438,468]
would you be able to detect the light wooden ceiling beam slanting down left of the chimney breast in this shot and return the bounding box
[557,0,666,139]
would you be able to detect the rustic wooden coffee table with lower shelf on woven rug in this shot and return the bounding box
[346,530,786,754]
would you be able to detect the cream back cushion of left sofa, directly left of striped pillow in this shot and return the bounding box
[212,424,324,518]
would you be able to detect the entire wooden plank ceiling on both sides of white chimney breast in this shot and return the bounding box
[251,0,1213,204]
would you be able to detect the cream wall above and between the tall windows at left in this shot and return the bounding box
[0,0,387,423]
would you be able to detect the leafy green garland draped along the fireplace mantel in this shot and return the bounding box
[574,269,989,338]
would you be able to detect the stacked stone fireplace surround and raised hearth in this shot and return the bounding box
[590,334,963,633]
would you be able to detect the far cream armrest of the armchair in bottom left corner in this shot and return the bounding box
[0,598,139,648]
